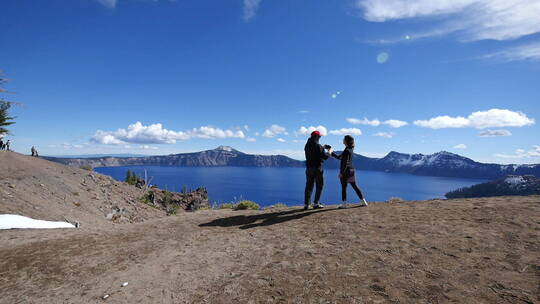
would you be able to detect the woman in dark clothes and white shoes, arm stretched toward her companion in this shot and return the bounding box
[332,135,368,208]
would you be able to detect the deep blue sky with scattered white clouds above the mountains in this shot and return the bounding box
[0,0,540,163]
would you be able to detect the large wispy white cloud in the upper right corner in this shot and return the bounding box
[357,0,540,40]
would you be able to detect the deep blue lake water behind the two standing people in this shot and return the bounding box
[95,166,484,206]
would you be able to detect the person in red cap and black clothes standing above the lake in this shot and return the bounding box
[304,131,331,210]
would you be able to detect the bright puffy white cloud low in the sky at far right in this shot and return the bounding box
[414,109,534,129]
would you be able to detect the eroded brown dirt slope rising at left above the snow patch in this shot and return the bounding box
[0,151,165,228]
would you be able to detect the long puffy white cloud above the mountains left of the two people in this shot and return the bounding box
[91,122,245,145]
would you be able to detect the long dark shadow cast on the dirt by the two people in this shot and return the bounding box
[199,206,361,229]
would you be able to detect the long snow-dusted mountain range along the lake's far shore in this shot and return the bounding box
[45,146,540,179]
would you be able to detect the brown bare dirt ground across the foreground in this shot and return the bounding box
[0,196,540,303]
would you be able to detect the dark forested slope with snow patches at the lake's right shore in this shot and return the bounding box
[445,175,540,198]
